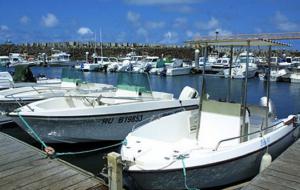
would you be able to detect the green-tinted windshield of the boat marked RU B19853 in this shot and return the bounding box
[117,72,152,94]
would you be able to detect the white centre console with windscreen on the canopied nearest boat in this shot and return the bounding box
[199,100,242,149]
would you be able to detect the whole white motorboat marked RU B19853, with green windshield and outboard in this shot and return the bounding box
[9,73,199,143]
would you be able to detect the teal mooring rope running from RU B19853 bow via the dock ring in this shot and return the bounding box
[18,112,127,158]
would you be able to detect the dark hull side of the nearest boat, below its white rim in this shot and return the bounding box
[124,128,297,189]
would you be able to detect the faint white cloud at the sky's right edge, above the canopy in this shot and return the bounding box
[274,11,299,31]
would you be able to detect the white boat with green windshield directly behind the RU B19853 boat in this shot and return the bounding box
[0,69,115,113]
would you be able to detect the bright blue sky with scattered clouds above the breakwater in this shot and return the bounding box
[0,0,300,47]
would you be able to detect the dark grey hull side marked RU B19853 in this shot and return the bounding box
[12,105,198,143]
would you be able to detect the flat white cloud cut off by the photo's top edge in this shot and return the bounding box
[125,0,199,5]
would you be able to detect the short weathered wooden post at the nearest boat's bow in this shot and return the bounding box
[107,152,123,190]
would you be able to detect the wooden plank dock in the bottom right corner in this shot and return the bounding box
[243,139,300,190]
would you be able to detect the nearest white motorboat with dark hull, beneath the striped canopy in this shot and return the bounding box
[121,100,299,189]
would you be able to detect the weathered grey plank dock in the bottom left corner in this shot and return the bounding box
[0,132,107,190]
